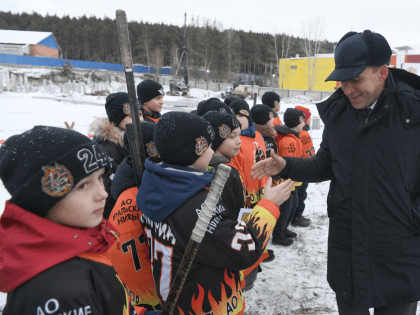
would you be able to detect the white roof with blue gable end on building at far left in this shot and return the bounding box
[0,30,60,49]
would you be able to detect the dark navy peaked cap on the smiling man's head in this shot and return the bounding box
[325,30,392,82]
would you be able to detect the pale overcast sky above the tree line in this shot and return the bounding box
[0,0,420,48]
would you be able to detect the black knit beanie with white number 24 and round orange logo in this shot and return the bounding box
[0,126,111,217]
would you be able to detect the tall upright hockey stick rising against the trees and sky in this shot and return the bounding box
[116,10,145,186]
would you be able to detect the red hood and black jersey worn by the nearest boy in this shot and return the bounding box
[0,202,134,315]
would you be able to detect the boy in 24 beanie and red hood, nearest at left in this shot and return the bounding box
[0,126,143,315]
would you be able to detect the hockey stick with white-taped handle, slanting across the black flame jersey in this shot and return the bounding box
[162,164,231,315]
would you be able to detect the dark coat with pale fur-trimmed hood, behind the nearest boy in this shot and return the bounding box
[90,118,129,219]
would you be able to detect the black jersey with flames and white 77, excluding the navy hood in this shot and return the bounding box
[141,196,279,315]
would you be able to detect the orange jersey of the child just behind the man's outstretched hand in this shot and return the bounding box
[232,121,267,208]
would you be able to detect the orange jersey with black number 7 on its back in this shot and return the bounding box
[108,187,160,310]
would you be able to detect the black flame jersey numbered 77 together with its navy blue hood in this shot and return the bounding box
[137,160,280,315]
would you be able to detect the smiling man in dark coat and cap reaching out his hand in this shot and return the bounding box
[251,30,420,315]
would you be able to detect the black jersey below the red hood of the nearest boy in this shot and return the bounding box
[3,253,133,315]
